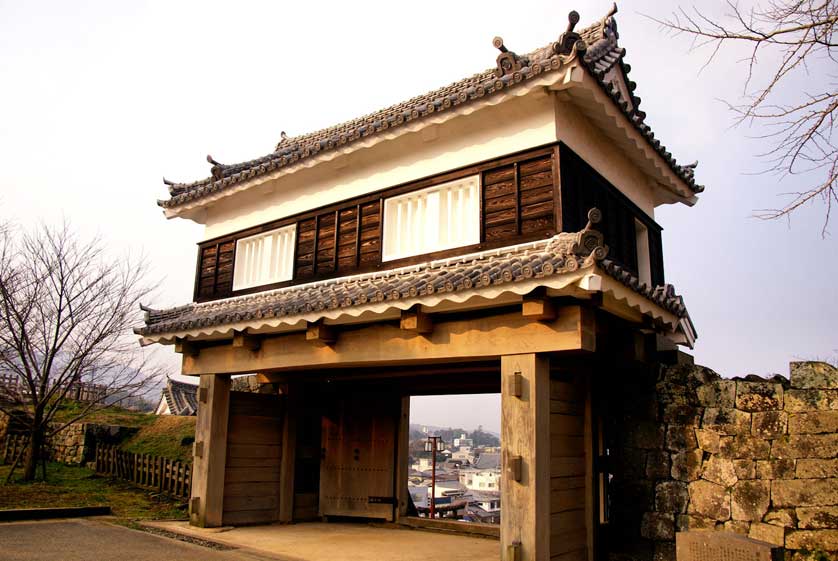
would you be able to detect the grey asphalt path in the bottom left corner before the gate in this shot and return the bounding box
[0,519,276,561]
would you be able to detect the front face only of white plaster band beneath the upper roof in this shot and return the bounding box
[204,90,557,239]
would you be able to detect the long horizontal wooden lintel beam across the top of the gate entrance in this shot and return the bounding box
[182,306,596,375]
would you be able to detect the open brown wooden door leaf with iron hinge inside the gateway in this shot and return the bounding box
[320,394,400,521]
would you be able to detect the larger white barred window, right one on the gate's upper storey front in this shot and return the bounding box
[382,175,480,261]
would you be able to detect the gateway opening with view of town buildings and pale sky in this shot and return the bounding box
[407,393,502,525]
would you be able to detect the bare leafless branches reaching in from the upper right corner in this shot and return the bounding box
[646,0,838,235]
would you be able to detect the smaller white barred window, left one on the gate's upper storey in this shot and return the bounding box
[233,224,297,290]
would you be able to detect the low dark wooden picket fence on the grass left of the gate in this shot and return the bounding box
[96,446,192,499]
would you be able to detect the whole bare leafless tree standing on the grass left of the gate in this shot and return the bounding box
[0,222,161,479]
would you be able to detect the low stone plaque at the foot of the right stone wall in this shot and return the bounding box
[675,531,783,561]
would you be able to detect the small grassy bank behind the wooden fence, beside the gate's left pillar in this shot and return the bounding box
[120,415,196,462]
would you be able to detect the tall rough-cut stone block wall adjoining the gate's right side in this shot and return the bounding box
[605,362,838,560]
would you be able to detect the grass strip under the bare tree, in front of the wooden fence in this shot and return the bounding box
[0,463,186,520]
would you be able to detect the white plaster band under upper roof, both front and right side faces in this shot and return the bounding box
[204,89,668,240]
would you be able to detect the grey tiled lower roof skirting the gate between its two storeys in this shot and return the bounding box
[135,209,687,336]
